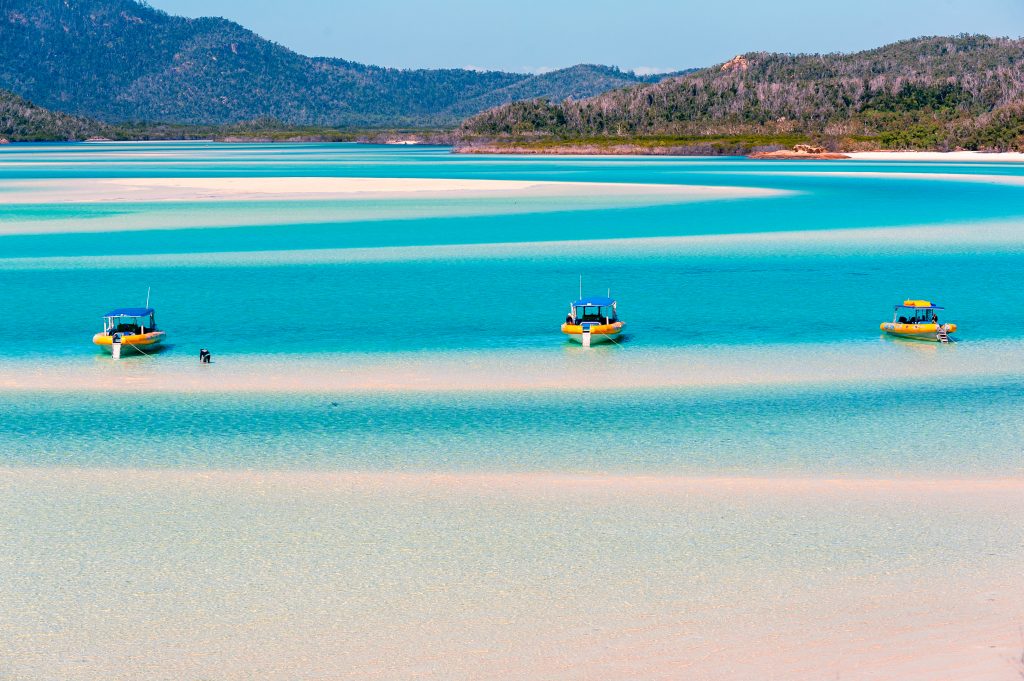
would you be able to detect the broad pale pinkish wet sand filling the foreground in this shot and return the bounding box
[0,469,1024,681]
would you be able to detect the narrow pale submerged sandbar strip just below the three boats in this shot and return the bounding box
[0,337,1024,394]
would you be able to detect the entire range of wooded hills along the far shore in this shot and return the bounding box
[0,0,1024,159]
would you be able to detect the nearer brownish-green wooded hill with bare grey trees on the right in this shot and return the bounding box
[461,36,1024,150]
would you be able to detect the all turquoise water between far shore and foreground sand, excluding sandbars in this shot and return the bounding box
[0,143,1024,476]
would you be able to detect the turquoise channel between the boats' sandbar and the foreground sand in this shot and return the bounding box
[6,379,1024,477]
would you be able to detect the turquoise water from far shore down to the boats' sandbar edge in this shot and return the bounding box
[0,143,1024,358]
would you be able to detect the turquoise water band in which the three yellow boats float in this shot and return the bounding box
[0,254,1024,358]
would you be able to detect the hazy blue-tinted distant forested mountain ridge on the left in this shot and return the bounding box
[0,0,663,126]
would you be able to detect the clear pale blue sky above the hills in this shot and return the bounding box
[150,0,1024,71]
